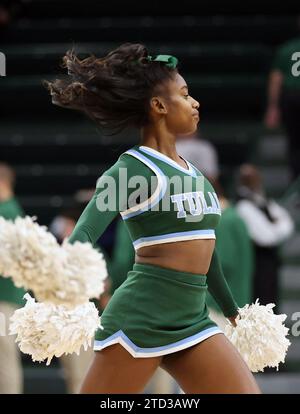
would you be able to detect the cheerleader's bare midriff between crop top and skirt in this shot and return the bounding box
[135,239,215,275]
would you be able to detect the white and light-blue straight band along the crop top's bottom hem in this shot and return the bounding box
[133,229,216,250]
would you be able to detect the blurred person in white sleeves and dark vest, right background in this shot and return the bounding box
[236,164,294,306]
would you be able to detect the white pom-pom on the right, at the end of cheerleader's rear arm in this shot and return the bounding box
[225,299,291,372]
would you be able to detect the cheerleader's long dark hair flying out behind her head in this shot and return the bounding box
[44,43,177,134]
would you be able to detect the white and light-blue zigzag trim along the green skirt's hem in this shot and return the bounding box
[94,326,224,358]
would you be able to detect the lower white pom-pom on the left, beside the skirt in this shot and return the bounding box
[10,293,101,365]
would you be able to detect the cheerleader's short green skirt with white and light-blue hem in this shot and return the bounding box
[94,264,222,358]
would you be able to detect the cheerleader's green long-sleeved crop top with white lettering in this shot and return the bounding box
[69,145,237,316]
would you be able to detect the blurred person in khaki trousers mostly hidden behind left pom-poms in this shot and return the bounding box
[49,207,110,394]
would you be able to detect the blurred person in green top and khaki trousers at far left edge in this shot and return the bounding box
[0,163,25,394]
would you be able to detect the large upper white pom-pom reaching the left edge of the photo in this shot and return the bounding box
[0,217,107,307]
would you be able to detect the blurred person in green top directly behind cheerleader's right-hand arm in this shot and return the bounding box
[207,181,254,329]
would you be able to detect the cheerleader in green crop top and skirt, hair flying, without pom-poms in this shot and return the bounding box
[43,43,260,394]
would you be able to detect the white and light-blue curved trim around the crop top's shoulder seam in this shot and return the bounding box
[120,149,167,220]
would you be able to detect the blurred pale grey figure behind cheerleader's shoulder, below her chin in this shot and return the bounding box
[176,133,219,180]
